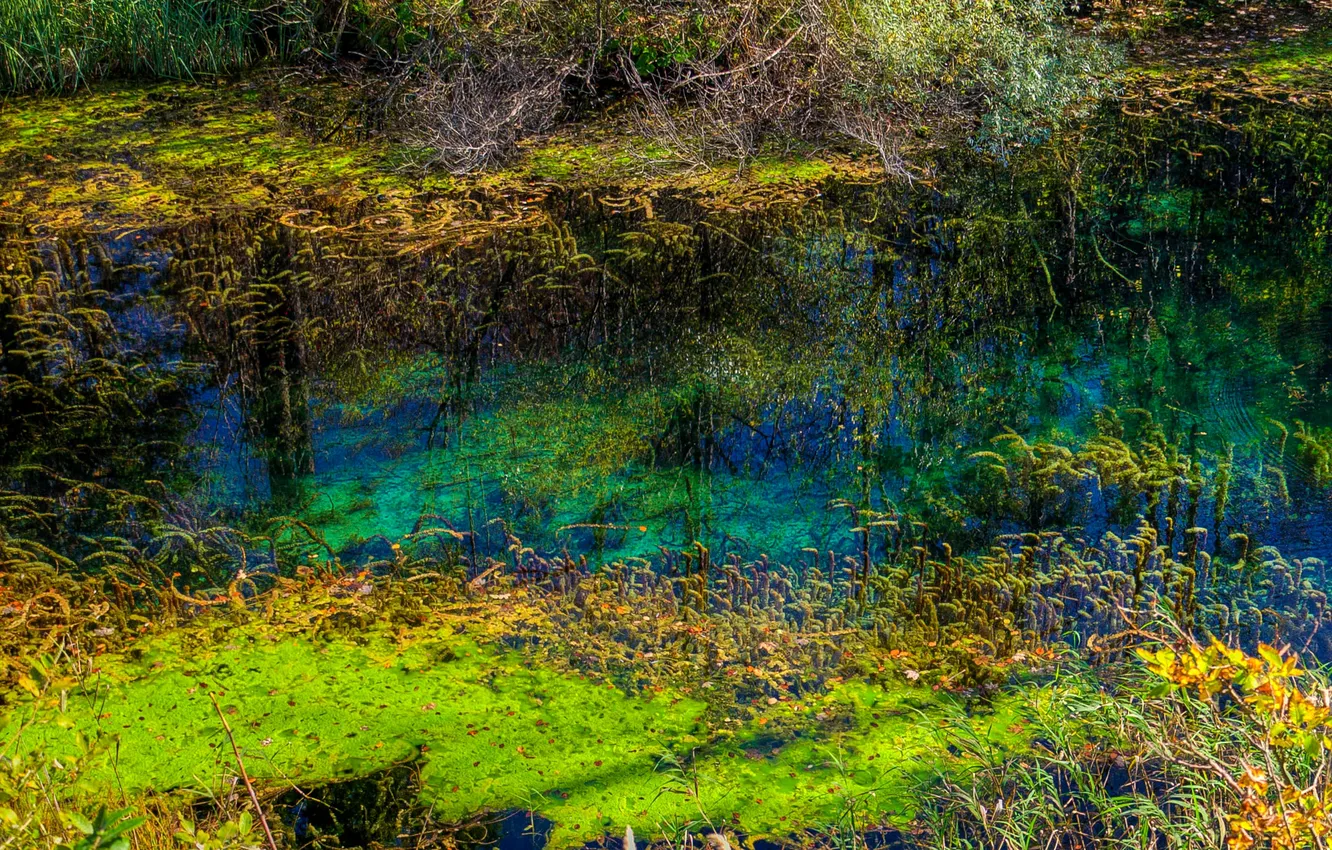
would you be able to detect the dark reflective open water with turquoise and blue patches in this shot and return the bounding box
[2,93,1332,580]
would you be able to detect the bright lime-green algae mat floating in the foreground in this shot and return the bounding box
[4,626,1020,847]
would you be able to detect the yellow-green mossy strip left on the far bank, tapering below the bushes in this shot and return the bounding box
[0,77,876,236]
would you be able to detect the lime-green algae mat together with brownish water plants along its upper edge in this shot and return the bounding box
[7,506,1321,846]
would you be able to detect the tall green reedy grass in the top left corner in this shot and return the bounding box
[0,0,310,92]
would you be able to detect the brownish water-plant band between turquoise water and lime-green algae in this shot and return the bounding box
[5,495,1323,847]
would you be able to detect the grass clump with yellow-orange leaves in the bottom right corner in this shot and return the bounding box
[923,633,1332,850]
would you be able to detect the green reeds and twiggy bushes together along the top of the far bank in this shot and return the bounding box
[0,0,1114,175]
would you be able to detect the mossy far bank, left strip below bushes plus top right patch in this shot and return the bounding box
[0,17,1332,237]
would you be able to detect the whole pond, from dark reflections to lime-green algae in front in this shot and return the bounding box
[0,68,1332,847]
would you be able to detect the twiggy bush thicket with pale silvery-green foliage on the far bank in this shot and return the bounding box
[380,0,1112,169]
